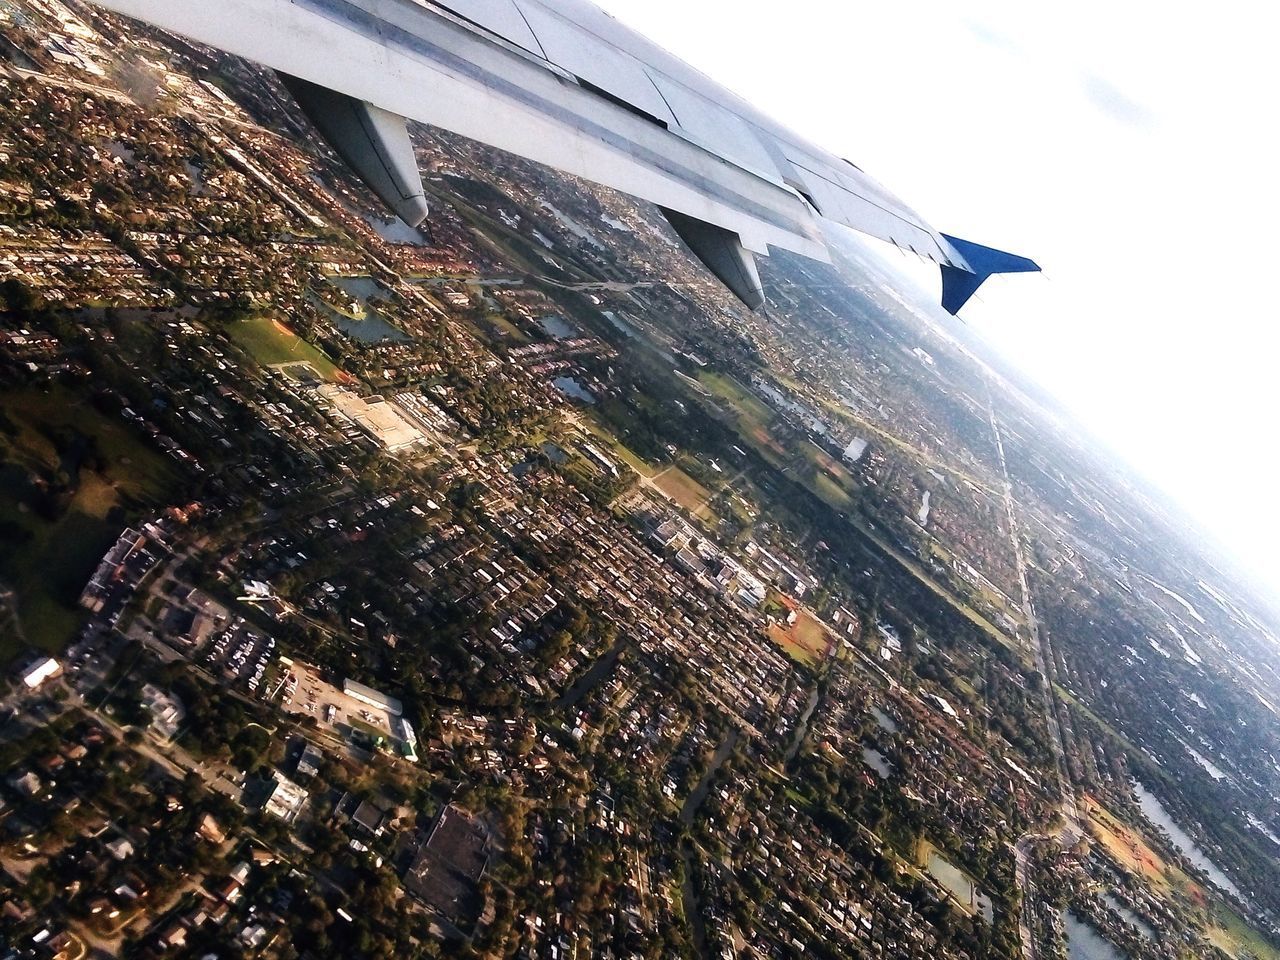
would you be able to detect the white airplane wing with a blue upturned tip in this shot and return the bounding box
[85,0,1038,312]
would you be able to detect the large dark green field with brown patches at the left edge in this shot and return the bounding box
[0,388,174,659]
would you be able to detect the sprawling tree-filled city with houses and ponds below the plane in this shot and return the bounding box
[0,0,1280,960]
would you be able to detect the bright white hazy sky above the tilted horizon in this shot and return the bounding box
[599,0,1280,595]
